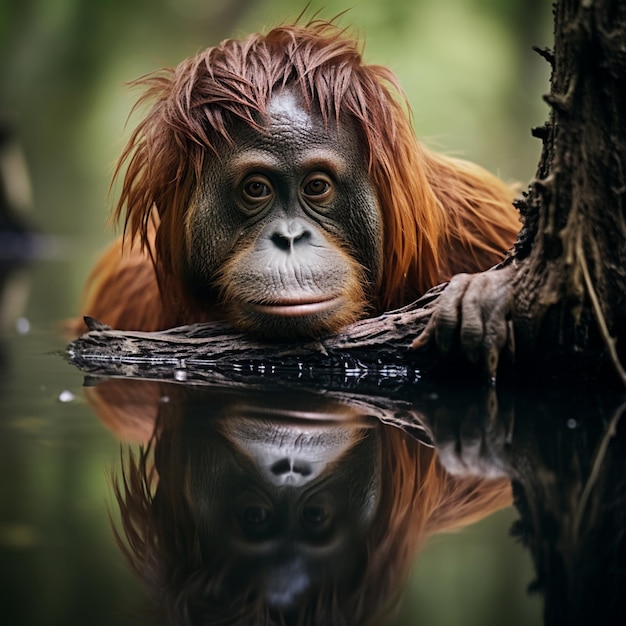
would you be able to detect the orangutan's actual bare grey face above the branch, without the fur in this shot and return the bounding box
[185,91,383,339]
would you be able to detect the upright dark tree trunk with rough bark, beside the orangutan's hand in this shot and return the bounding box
[512,0,626,382]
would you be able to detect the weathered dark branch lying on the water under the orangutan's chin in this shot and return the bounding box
[67,285,445,380]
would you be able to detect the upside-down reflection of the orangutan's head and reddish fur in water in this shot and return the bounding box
[88,380,510,624]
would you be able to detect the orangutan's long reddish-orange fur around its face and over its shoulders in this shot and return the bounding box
[75,20,520,330]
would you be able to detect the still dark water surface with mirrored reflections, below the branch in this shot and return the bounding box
[0,252,626,626]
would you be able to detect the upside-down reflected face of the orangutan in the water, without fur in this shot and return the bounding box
[178,400,381,608]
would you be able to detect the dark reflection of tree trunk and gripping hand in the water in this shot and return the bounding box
[419,388,626,626]
